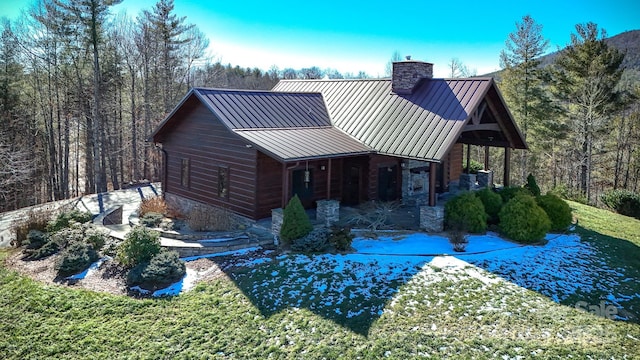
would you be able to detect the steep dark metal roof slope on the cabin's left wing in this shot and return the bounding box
[193,88,331,129]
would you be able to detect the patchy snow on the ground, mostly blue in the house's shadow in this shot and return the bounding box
[116,233,640,319]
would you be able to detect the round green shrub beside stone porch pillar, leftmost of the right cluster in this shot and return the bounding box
[444,192,487,233]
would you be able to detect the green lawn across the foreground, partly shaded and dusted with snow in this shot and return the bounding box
[0,203,640,359]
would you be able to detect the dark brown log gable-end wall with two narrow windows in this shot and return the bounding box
[162,102,257,219]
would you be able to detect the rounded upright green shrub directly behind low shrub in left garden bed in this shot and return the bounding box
[117,226,161,267]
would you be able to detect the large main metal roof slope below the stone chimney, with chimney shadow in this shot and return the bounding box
[273,78,526,161]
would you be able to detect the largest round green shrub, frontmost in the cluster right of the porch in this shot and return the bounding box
[498,194,551,244]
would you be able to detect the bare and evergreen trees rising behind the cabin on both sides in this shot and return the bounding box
[0,0,640,212]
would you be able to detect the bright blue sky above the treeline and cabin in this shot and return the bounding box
[0,0,640,77]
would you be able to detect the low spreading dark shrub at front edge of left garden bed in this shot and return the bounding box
[127,250,187,290]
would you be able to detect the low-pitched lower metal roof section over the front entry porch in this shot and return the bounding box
[234,127,372,161]
